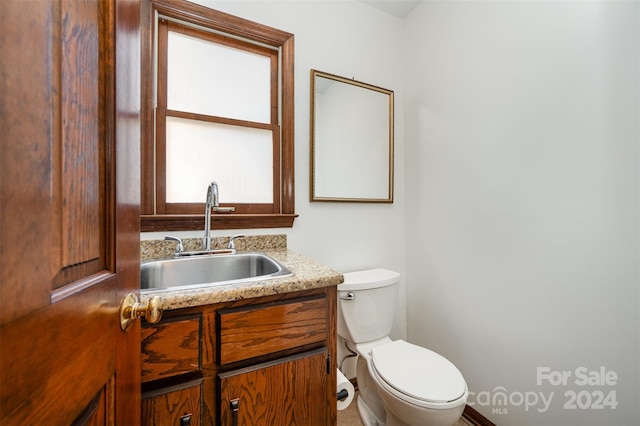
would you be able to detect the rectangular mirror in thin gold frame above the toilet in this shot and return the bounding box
[310,69,393,203]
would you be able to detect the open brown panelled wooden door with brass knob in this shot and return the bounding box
[0,0,140,426]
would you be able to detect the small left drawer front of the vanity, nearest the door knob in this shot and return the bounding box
[142,315,202,382]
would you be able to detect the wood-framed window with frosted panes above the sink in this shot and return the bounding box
[141,0,296,231]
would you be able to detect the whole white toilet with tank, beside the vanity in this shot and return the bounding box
[338,269,469,426]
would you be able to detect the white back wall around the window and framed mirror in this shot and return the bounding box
[142,0,406,337]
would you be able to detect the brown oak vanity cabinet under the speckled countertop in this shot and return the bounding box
[142,287,336,426]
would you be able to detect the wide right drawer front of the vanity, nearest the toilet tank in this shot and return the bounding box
[218,296,327,364]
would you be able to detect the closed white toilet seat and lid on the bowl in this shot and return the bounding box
[371,340,467,408]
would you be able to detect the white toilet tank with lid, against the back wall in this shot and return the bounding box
[338,269,400,343]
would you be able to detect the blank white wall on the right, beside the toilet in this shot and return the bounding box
[405,1,640,426]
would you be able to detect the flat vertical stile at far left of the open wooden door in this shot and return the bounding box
[0,1,59,326]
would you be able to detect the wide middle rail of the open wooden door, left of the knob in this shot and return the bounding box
[0,276,117,425]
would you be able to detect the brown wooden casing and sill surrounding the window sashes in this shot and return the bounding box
[140,0,298,232]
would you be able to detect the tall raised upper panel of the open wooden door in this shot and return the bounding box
[60,0,103,270]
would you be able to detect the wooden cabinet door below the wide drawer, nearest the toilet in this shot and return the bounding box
[218,349,329,426]
